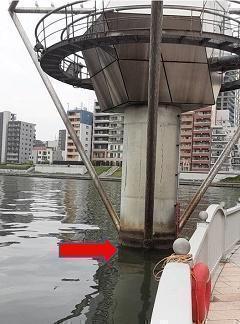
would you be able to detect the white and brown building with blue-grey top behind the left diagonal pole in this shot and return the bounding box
[66,108,93,161]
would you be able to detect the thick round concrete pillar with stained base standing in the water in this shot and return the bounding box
[120,105,180,248]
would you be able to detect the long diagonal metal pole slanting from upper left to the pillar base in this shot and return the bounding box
[9,5,120,231]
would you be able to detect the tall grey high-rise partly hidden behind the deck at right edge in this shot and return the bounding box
[216,71,240,126]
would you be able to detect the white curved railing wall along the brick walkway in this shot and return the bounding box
[151,204,240,324]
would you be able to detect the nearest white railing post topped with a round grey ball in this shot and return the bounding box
[151,238,192,324]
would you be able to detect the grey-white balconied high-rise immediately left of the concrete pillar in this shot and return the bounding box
[92,102,124,166]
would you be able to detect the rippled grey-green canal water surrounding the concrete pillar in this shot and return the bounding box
[0,176,239,324]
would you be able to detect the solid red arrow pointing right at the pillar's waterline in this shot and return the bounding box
[59,240,117,261]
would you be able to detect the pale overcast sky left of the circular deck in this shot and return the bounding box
[0,0,95,140]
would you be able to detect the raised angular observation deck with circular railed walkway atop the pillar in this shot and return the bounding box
[35,1,240,110]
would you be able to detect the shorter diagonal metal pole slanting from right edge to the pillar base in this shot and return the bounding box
[179,126,240,230]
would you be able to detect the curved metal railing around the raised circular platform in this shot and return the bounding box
[35,0,240,84]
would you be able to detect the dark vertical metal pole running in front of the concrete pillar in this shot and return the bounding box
[144,1,163,247]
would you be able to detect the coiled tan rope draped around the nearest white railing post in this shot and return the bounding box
[153,253,192,281]
